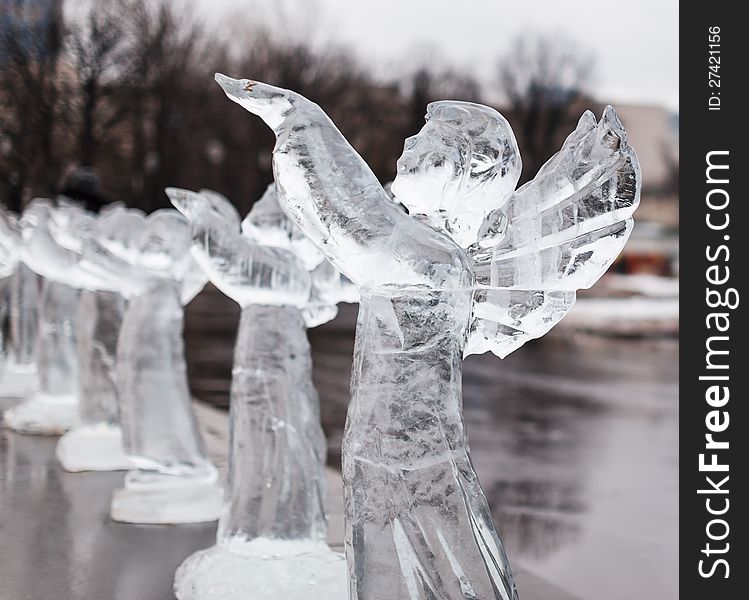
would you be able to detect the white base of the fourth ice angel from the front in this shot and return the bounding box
[57,423,135,473]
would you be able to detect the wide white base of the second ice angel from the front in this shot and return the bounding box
[174,538,348,600]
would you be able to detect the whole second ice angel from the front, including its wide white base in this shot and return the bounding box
[167,185,356,600]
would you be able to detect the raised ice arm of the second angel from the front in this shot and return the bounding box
[167,188,310,306]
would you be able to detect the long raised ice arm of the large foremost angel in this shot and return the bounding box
[216,74,466,287]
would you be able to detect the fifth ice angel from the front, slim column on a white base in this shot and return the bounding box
[4,200,78,435]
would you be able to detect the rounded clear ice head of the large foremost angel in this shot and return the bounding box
[392,101,522,248]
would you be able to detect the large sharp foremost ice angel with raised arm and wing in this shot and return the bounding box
[216,75,640,600]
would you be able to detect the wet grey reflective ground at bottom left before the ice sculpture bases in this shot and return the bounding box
[0,422,216,600]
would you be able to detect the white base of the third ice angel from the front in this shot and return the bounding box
[111,471,223,525]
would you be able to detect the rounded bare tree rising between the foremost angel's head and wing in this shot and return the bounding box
[498,34,594,180]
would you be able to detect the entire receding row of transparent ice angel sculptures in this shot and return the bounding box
[0,75,640,600]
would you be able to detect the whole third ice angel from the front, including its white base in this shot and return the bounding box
[99,209,221,523]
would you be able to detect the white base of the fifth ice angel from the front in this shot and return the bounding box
[3,393,78,435]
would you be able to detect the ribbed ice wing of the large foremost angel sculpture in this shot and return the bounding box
[466,107,641,357]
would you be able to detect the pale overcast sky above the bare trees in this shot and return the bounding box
[200,0,679,110]
